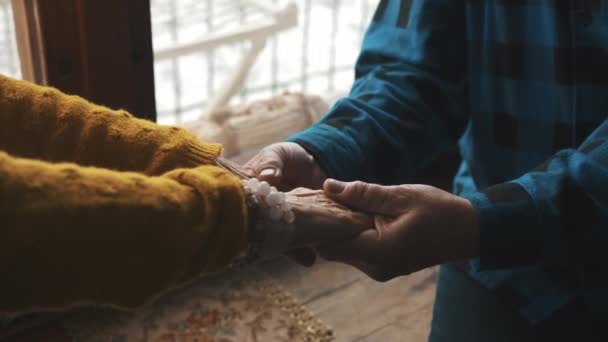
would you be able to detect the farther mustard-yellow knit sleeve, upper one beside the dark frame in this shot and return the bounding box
[0,75,221,175]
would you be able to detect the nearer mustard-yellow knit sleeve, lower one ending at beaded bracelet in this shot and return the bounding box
[0,152,248,313]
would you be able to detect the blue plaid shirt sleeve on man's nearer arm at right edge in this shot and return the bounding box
[463,119,608,276]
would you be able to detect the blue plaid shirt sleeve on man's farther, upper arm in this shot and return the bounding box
[289,0,468,184]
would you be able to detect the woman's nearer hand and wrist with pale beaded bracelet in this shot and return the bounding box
[243,179,374,265]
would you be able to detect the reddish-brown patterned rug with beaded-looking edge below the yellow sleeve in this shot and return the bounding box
[0,271,333,342]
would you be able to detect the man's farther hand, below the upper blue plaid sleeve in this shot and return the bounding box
[243,142,327,191]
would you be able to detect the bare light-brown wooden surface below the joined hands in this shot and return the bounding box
[258,259,438,342]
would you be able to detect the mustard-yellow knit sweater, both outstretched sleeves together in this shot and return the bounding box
[0,75,247,312]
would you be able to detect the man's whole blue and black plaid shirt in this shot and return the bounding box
[290,0,608,325]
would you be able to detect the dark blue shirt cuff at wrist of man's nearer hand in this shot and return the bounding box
[462,182,547,271]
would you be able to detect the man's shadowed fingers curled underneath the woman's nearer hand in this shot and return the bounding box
[317,229,381,265]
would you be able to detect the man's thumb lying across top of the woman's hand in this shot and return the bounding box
[323,179,395,215]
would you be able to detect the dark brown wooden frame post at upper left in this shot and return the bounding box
[12,0,156,121]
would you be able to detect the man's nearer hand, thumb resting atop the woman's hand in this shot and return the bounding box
[318,180,479,281]
